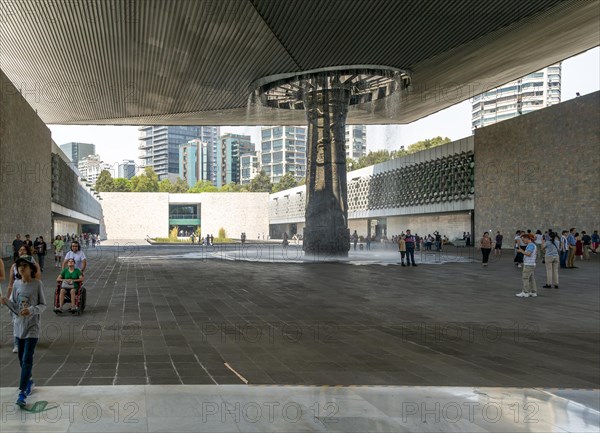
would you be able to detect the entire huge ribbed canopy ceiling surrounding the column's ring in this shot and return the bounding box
[0,0,600,125]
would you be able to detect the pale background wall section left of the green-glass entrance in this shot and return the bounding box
[100,192,169,240]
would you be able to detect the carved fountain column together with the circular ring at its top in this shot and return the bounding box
[249,65,410,256]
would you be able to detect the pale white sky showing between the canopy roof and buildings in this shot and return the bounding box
[48,47,600,166]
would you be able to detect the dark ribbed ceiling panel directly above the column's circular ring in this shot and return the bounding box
[252,0,562,70]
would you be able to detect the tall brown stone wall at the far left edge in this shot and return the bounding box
[0,71,52,256]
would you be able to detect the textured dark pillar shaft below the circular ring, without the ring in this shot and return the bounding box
[304,76,350,256]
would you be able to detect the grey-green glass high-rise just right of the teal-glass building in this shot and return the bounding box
[216,134,255,188]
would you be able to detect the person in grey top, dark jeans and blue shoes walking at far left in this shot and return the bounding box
[0,256,46,407]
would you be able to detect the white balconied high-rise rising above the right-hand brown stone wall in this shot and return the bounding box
[471,63,561,129]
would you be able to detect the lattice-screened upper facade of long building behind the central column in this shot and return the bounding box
[269,137,475,224]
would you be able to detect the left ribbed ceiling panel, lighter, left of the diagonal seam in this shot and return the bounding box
[0,0,297,122]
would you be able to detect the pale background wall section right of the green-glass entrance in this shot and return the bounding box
[199,192,269,240]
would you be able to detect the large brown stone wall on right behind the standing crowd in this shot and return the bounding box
[475,92,600,239]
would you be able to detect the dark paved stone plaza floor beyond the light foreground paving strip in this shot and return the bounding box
[0,244,600,389]
